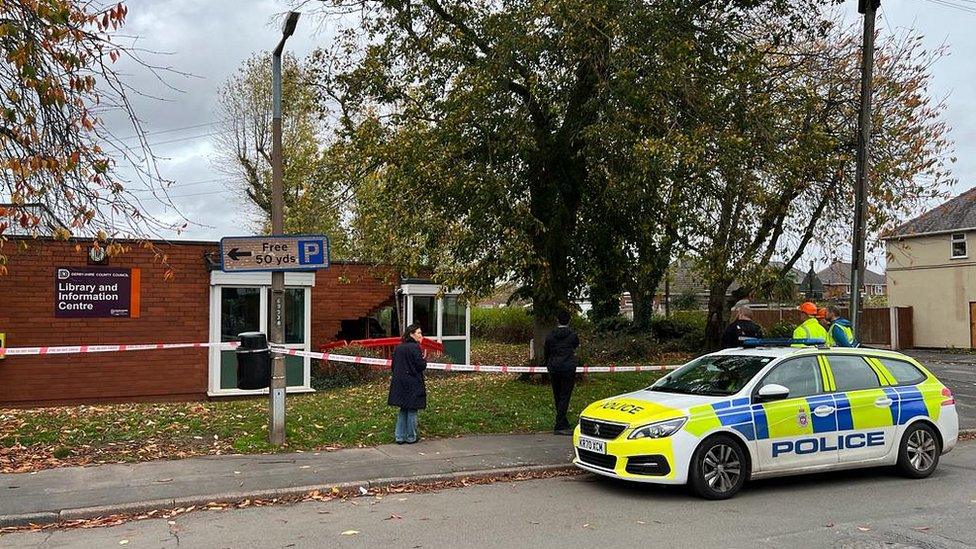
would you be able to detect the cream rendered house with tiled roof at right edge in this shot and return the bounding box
[884,188,976,348]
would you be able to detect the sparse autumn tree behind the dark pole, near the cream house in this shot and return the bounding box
[685,24,950,347]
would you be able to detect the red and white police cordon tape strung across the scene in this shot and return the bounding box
[0,341,681,374]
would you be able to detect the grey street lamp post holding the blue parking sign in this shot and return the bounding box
[268,11,300,446]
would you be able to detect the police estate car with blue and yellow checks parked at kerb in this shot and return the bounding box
[573,340,959,499]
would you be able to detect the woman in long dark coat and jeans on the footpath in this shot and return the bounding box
[387,324,427,444]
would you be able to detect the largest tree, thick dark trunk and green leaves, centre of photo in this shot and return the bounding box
[304,0,819,352]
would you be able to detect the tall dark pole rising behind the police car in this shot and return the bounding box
[850,0,881,340]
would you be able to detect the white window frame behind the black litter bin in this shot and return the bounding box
[207,271,315,396]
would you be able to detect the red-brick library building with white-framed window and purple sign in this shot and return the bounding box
[0,237,396,406]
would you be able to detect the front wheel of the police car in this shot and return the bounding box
[689,435,749,499]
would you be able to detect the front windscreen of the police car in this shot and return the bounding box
[649,355,773,396]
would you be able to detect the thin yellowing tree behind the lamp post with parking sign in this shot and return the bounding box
[215,54,349,257]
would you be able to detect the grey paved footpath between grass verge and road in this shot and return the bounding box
[0,433,573,526]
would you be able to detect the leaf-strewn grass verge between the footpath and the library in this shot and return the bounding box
[0,372,659,473]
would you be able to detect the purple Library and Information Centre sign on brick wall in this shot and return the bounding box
[54,267,140,318]
